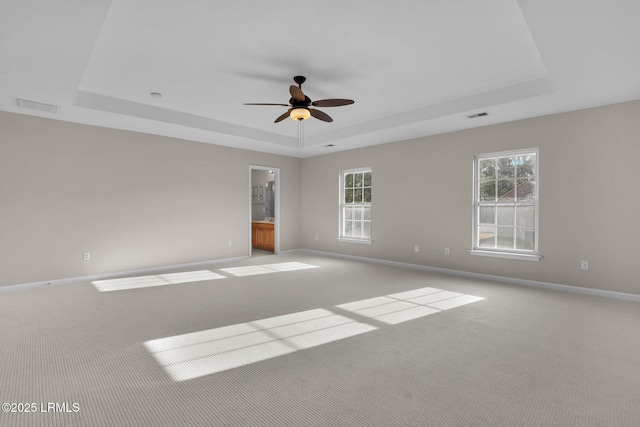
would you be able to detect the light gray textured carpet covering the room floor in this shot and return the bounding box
[0,253,640,427]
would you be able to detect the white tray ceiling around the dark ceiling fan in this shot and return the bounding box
[0,0,640,157]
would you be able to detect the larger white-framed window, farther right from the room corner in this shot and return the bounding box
[472,149,540,260]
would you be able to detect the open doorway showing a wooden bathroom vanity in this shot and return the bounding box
[249,165,280,257]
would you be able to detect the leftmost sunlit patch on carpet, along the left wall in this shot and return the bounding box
[91,270,225,292]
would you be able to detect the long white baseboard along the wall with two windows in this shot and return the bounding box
[299,249,640,302]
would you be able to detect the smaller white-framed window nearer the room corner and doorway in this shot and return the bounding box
[340,168,371,243]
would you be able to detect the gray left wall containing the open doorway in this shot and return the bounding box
[0,113,301,286]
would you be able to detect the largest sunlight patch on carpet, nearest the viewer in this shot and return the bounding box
[145,309,377,381]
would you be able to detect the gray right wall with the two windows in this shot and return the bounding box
[302,101,640,294]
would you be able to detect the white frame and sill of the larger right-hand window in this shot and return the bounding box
[469,148,542,261]
